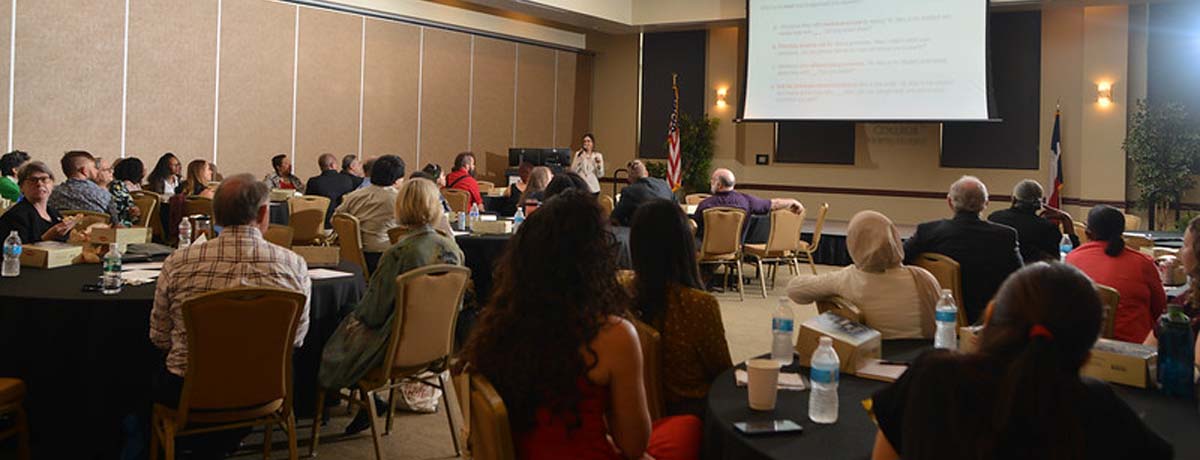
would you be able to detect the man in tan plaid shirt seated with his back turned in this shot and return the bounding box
[150,174,312,458]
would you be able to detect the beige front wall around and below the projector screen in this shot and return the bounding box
[588,6,1136,223]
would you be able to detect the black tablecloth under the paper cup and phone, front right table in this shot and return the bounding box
[702,340,1200,459]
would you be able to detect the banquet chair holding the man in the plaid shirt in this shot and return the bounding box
[150,287,305,460]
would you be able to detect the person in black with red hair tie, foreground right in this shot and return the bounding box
[864,263,1174,460]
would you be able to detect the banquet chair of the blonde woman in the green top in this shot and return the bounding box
[308,264,470,460]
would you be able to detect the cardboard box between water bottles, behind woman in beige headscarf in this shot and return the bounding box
[796,312,883,374]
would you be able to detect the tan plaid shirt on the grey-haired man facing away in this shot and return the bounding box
[150,226,312,376]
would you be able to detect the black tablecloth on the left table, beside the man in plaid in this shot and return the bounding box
[0,263,365,459]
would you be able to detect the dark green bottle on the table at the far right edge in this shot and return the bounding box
[1158,304,1195,399]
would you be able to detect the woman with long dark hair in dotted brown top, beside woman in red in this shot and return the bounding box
[626,199,733,417]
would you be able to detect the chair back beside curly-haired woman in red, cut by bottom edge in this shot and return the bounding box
[467,374,516,460]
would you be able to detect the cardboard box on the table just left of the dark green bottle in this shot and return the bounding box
[1080,339,1158,388]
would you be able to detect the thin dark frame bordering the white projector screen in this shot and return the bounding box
[733,0,1004,124]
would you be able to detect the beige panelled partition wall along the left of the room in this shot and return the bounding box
[0,0,587,180]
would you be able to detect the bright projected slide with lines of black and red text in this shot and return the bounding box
[743,0,988,120]
